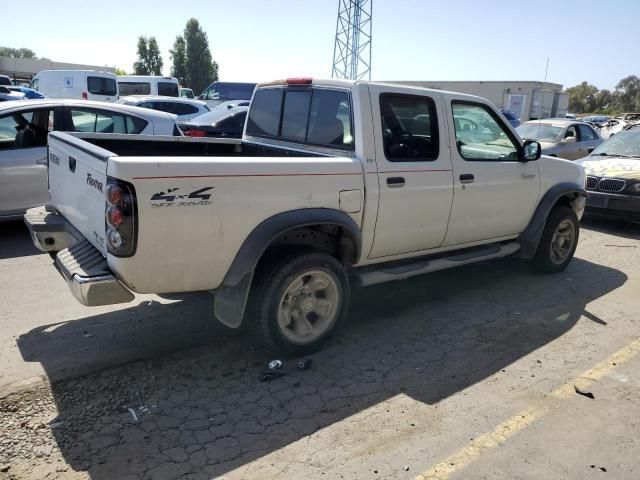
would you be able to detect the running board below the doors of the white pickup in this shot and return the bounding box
[351,242,520,287]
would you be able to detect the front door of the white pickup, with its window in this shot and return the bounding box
[444,98,540,246]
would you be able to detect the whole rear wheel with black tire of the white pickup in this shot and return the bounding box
[247,252,350,355]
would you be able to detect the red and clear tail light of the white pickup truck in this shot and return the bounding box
[105,177,138,257]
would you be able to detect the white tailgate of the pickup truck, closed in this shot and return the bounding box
[49,132,113,256]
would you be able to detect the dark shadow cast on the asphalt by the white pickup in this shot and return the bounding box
[19,258,627,480]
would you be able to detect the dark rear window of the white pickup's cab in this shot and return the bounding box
[247,88,354,150]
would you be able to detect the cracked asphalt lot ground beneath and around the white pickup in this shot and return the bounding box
[0,220,640,480]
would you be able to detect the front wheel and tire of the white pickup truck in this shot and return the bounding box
[529,205,580,273]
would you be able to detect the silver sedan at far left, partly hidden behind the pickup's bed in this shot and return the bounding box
[0,99,181,220]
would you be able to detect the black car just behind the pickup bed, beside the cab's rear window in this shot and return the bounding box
[178,103,249,138]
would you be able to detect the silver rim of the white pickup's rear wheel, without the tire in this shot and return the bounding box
[278,270,340,343]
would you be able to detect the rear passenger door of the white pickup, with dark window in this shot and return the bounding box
[369,85,452,258]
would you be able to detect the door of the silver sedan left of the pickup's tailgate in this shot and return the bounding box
[0,109,53,215]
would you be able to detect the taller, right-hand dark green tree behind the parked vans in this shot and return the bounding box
[184,18,218,92]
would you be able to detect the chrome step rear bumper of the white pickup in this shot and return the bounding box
[24,207,134,307]
